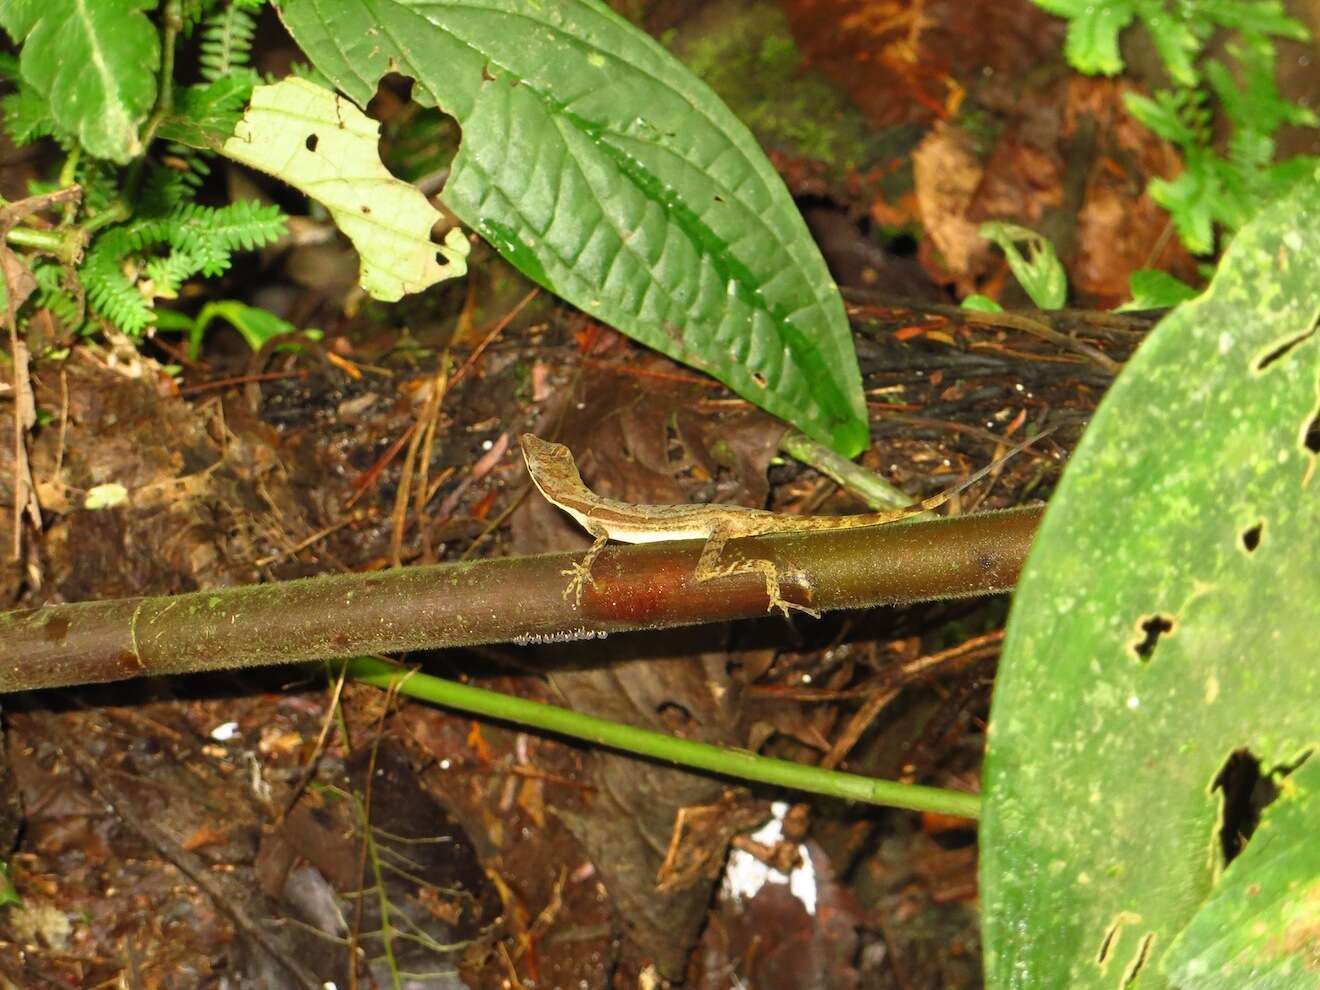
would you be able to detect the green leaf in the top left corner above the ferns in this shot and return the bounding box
[0,0,160,162]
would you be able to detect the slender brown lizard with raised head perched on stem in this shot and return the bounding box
[523,430,1052,618]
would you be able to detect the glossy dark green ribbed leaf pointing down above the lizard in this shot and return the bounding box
[280,0,869,455]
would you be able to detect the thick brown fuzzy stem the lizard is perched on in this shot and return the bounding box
[0,508,1040,692]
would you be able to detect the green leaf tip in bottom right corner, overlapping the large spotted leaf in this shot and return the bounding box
[1164,756,1320,990]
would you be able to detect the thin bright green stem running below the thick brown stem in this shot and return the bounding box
[347,657,981,818]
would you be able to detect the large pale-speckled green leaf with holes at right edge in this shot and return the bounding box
[981,170,1320,990]
